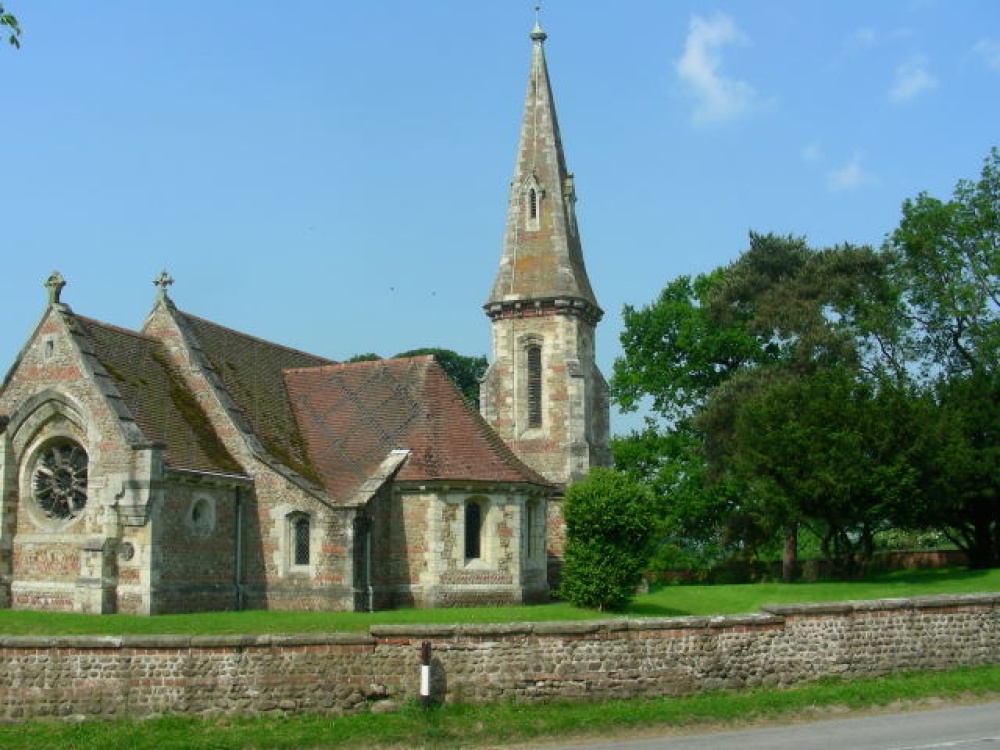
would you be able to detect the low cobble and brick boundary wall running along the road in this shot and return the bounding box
[0,594,1000,720]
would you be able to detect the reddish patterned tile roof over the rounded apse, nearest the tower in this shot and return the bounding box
[285,357,549,502]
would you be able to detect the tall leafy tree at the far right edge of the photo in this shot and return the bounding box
[888,149,1000,567]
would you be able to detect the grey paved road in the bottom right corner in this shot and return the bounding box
[555,702,1000,750]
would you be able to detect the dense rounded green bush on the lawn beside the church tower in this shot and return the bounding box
[559,467,657,610]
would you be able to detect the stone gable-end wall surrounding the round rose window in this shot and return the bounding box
[0,309,156,612]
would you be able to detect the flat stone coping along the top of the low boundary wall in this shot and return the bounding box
[0,593,1000,650]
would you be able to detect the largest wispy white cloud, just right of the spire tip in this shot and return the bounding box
[674,13,757,123]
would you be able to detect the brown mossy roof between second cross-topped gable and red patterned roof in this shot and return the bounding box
[175,311,333,480]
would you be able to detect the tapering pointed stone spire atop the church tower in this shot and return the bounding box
[485,13,603,322]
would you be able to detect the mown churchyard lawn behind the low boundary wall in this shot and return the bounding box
[0,569,1000,635]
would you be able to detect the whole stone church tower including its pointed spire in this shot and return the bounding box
[481,22,611,485]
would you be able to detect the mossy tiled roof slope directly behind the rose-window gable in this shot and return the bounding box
[74,316,243,473]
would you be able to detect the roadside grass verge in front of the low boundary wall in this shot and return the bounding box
[0,666,1000,750]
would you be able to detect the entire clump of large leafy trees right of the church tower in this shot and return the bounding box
[612,150,1000,572]
